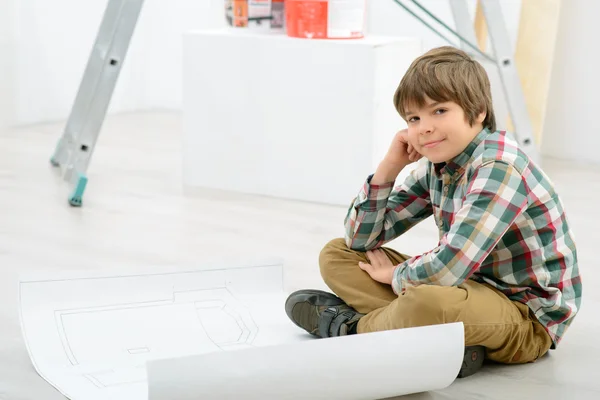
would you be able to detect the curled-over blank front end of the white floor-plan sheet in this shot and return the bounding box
[148,323,464,400]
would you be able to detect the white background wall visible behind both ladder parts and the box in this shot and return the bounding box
[12,0,600,163]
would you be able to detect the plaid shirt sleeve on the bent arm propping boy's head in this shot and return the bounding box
[344,163,433,251]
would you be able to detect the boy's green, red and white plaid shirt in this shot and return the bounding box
[345,129,582,348]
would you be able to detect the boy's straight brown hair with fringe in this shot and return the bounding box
[394,46,496,132]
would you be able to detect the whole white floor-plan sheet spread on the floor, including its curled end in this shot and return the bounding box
[19,262,464,400]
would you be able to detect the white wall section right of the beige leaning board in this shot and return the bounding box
[542,0,600,164]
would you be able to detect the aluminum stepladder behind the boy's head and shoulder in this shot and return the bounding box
[393,0,541,164]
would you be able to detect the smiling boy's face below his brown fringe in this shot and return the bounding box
[406,97,485,163]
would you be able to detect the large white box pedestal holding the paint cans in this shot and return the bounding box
[183,30,421,206]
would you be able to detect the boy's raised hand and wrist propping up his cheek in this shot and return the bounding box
[371,129,423,184]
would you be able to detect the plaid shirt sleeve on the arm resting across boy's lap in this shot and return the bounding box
[392,161,529,293]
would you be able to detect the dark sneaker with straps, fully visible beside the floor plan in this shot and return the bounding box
[285,290,364,338]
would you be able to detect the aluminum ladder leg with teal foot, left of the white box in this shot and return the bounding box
[50,0,144,207]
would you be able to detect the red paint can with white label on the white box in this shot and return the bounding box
[285,0,367,39]
